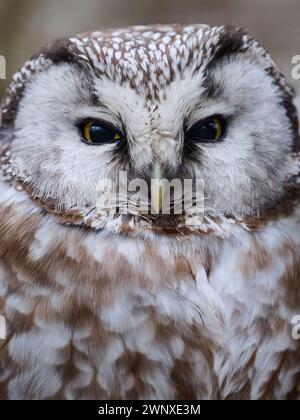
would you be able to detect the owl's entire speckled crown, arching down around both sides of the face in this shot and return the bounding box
[1,24,293,125]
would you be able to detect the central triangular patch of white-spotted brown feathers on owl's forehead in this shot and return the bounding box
[69,25,223,96]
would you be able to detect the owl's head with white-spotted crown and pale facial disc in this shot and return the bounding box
[2,26,297,233]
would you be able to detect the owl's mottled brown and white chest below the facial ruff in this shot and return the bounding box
[2,220,300,399]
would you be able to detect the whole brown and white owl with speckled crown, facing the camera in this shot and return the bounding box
[0,25,300,400]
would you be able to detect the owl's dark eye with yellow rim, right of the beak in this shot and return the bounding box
[186,116,225,143]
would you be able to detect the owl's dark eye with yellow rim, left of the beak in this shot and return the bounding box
[80,121,121,145]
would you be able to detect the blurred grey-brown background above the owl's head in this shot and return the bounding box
[0,0,300,97]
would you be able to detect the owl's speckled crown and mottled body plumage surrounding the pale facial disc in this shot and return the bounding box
[0,25,300,399]
